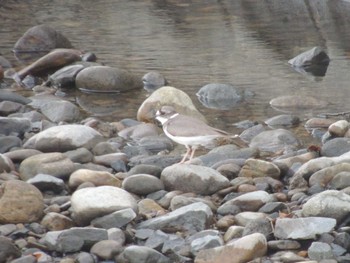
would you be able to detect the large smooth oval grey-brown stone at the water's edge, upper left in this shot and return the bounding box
[75,66,143,93]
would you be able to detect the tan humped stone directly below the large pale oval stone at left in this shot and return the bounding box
[19,152,76,181]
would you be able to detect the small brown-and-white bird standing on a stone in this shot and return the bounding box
[155,105,247,163]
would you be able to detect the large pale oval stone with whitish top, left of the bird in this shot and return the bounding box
[24,124,103,152]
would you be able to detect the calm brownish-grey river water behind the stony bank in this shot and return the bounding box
[0,0,350,144]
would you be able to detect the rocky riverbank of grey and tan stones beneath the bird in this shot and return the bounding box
[0,24,350,263]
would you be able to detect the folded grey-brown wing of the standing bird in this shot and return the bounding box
[164,115,229,137]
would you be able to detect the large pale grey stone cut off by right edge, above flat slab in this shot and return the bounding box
[302,190,350,222]
